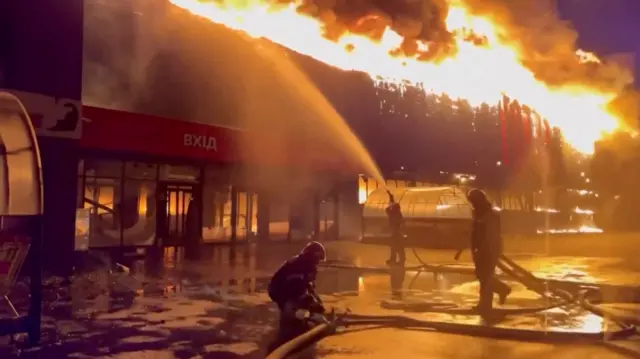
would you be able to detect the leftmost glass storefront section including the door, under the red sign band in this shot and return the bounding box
[78,159,208,247]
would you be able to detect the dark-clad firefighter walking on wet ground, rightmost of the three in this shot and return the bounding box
[456,189,511,314]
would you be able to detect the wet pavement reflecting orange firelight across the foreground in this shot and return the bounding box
[0,243,640,358]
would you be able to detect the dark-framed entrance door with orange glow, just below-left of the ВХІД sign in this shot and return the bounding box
[157,183,193,246]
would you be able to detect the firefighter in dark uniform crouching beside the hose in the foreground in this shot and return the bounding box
[268,241,327,353]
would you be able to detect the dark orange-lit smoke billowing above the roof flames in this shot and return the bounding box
[270,0,633,91]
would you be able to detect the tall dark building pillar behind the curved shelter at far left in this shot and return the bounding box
[0,0,83,275]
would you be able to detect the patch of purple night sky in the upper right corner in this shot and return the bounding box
[556,0,640,87]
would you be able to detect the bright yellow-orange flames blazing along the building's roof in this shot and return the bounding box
[170,0,619,154]
